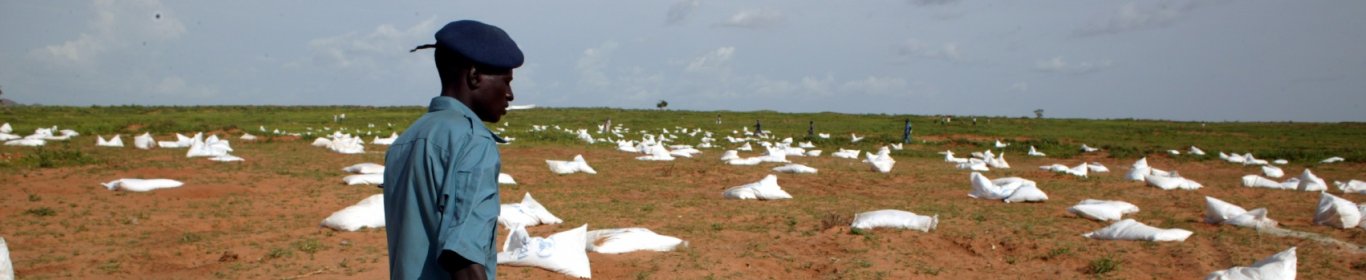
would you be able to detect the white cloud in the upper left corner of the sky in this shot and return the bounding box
[30,0,186,70]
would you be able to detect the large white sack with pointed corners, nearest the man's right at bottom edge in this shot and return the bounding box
[497,224,593,279]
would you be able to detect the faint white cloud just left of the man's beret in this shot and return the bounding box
[301,18,436,71]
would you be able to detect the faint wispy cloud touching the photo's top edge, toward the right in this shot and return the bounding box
[1075,0,1223,37]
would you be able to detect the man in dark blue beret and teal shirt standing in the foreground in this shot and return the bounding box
[384,20,523,279]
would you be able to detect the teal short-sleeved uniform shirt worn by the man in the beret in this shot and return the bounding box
[384,97,504,279]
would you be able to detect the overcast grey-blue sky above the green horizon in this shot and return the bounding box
[0,0,1366,122]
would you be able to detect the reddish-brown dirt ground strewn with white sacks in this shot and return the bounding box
[0,135,1366,279]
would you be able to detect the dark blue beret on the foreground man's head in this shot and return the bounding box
[436,19,523,70]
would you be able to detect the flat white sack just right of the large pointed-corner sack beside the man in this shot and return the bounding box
[585,228,687,254]
